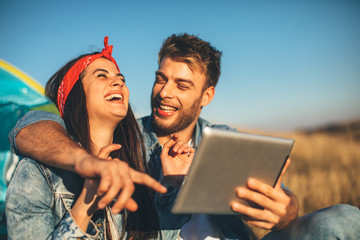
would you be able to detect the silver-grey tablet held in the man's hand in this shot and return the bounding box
[172,128,294,214]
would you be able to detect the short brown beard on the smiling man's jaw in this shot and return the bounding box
[151,95,201,136]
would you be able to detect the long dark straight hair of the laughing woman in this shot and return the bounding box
[45,52,159,239]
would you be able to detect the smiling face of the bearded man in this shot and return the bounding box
[151,57,206,135]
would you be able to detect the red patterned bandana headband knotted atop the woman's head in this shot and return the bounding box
[57,36,120,117]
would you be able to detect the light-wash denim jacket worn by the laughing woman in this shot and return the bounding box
[5,158,122,239]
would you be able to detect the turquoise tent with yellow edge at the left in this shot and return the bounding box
[0,59,53,234]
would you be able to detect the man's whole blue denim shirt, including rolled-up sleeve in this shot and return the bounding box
[7,111,250,240]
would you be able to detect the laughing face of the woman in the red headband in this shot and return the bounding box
[81,58,129,122]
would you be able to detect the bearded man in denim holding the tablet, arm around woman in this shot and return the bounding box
[9,34,360,239]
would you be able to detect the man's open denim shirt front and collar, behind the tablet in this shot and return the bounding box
[138,116,249,240]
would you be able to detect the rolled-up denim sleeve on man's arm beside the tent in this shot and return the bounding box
[8,111,65,156]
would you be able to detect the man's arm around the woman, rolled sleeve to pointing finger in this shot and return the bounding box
[9,112,164,211]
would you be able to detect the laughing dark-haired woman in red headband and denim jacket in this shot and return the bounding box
[6,37,193,239]
